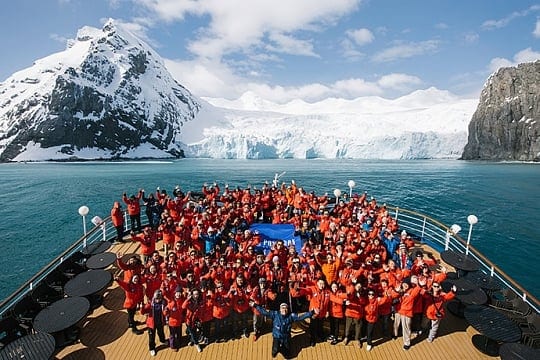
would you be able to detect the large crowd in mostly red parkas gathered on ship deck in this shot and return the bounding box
[111,181,455,357]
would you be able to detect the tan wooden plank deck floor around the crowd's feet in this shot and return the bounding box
[55,239,493,360]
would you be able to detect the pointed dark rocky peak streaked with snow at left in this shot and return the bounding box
[0,20,200,161]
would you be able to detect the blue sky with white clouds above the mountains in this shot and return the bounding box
[0,0,540,103]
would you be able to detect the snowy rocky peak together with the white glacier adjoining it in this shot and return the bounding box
[0,20,477,161]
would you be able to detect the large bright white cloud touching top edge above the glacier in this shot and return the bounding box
[135,0,360,58]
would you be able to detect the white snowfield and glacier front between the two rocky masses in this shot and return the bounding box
[184,88,477,159]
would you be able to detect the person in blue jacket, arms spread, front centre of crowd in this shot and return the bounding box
[249,300,317,359]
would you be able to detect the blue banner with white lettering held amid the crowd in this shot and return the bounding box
[249,223,302,255]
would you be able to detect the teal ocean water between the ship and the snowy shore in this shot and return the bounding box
[0,159,540,299]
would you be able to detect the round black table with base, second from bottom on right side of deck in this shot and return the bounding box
[464,305,521,356]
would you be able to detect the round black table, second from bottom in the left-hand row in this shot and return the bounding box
[34,297,90,334]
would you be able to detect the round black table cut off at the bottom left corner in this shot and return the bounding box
[0,332,55,360]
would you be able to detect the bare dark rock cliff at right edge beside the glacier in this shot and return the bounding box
[462,61,540,161]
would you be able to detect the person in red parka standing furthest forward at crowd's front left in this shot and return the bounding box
[141,290,169,356]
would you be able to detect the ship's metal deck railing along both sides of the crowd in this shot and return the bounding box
[0,206,540,316]
